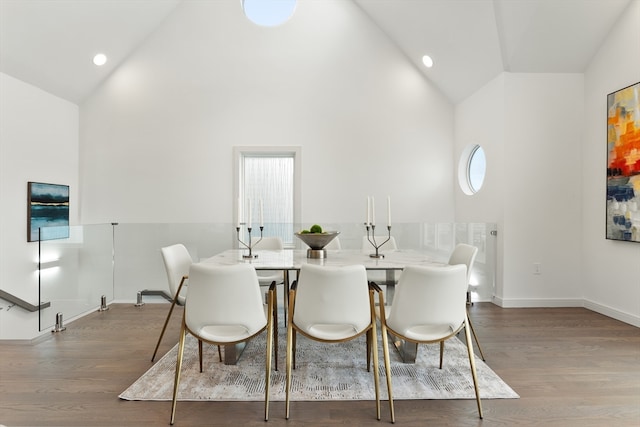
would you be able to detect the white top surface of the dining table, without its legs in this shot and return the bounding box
[201,249,443,270]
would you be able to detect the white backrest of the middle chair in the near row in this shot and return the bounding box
[293,264,371,336]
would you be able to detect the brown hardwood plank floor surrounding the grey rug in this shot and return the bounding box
[0,303,640,427]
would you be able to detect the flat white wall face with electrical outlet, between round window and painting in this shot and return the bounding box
[501,74,584,307]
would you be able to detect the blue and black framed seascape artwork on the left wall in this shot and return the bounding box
[27,182,69,242]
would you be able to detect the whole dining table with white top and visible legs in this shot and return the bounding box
[200,249,444,365]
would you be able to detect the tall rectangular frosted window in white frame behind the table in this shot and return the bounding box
[234,147,300,247]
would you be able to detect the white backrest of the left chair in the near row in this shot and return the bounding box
[185,263,267,335]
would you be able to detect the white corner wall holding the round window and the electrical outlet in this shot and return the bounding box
[456,73,583,307]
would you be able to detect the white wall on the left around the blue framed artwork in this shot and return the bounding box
[0,73,79,339]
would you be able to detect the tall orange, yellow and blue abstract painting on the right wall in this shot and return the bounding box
[606,82,640,242]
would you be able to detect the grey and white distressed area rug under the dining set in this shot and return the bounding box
[119,328,519,401]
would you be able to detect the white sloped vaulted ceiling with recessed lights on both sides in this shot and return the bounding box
[0,0,632,104]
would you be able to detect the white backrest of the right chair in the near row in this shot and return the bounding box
[387,264,467,339]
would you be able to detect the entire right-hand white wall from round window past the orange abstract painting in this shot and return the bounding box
[455,0,640,326]
